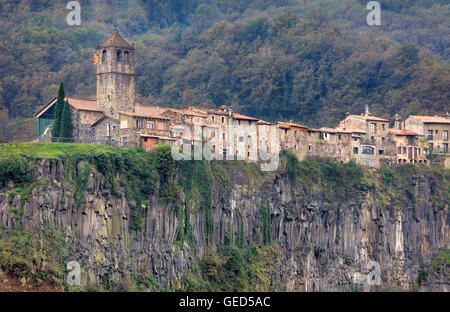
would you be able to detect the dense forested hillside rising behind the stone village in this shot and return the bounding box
[0,0,450,142]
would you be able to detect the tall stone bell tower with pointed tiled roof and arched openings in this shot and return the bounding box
[97,31,135,115]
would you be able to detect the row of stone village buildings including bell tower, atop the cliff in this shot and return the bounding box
[35,32,450,167]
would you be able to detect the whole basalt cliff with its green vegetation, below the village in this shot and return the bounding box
[0,148,450,291]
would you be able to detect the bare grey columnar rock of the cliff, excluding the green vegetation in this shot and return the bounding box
[0,160,450,291]
